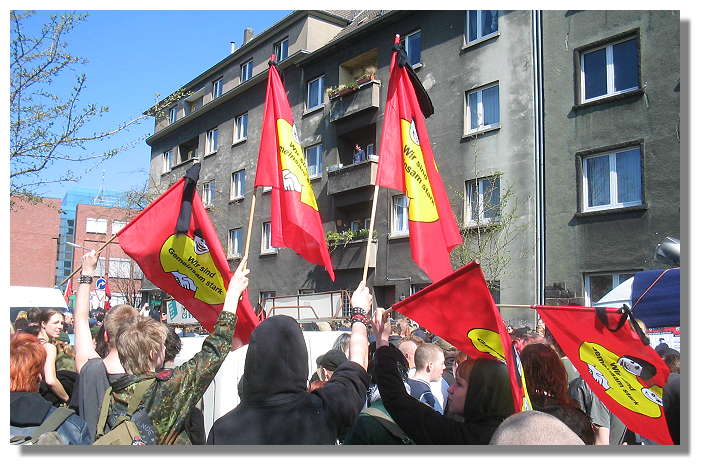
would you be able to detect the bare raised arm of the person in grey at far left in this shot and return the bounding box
[73,250,100,372]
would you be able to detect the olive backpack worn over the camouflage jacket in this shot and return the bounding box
[93,379,154,446]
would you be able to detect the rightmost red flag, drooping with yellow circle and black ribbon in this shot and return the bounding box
[535,305,673,444]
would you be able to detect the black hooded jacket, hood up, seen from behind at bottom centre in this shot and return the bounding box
[207,315,369,444]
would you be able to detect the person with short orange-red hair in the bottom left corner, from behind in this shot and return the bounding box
[10,333,91,445]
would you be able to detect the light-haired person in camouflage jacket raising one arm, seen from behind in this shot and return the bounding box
[106,263,249,445]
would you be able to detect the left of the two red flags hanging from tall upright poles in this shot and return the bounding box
[255,57,335,281]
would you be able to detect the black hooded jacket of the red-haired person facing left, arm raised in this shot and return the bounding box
[375,346,514,444]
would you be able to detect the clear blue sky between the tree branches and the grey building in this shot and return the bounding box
[11,10,290,198]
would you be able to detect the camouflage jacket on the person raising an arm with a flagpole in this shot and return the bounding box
[108,311,237,445]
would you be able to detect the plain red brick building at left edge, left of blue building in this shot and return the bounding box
[10,197,61,287]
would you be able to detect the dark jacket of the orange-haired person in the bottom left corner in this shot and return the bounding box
[10,392,93,445]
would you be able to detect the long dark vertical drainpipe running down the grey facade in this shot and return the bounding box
[531,10,546,305]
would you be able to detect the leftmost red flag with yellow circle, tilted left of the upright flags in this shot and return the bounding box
[118,171,259,344]
